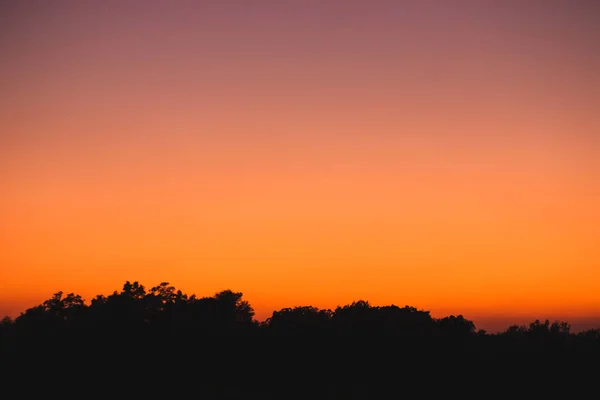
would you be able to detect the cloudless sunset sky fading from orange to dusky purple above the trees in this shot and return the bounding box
[0,0,600,331]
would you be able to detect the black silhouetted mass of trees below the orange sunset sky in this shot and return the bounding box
[0,282,600,399]
